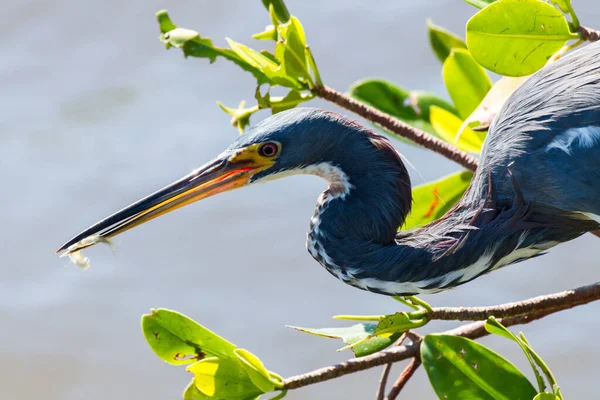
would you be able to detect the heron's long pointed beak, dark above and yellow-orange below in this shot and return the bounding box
[57,146,274,255]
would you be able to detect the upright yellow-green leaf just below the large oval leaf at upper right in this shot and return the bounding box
[442,49,492,118]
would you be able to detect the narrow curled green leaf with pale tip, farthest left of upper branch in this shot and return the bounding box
[156,10,271,85]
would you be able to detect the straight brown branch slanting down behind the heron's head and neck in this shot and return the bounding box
[313,85,477,171]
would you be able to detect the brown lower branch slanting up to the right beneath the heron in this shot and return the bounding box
[283,282,600,389]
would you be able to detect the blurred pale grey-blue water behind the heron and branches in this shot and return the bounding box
[0,0,600,400]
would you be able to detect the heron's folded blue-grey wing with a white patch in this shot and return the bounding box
[467,42,600,215]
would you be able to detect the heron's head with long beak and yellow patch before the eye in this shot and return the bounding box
[58,108,410,253]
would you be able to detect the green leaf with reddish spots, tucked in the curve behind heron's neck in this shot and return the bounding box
[402,171,473,229]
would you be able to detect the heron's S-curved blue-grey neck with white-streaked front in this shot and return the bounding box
[296,125,543,295]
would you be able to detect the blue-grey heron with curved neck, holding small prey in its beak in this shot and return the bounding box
[59,43,600,295]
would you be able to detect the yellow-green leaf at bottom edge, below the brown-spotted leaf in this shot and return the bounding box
[187,357,264,400]
